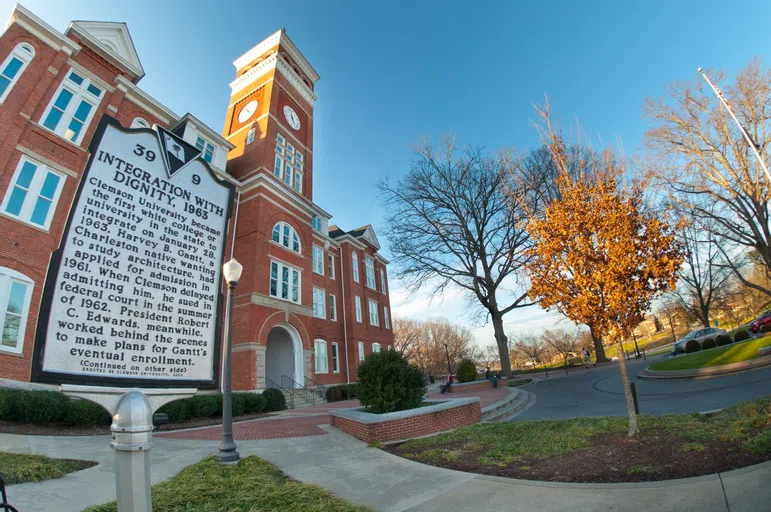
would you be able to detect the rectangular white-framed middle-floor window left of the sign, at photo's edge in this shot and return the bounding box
[2,156,64,229]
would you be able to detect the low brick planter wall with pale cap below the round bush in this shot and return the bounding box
[329,397,482,443]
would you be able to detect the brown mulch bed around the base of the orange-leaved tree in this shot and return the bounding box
[385,433,771,483]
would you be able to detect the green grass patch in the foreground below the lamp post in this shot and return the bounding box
[84,456,371,512]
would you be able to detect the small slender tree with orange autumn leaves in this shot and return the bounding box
[527,110,683,436]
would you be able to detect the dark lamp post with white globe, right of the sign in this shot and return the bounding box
[217,258,244,464]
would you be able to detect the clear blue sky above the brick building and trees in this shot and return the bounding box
[7,0,771,344]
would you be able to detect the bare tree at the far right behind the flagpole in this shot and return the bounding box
[645,59,771,295]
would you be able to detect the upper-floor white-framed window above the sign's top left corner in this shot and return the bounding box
[41,70,104,144]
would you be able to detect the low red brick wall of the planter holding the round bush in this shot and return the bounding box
[330,402,482,443]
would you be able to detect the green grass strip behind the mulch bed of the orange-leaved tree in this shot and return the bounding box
[399,397,771,466]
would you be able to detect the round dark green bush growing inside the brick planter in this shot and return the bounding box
[356,350,426,414]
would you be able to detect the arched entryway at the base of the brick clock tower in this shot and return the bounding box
[265,323,305,388]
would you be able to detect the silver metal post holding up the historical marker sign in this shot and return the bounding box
[110,391,153,512]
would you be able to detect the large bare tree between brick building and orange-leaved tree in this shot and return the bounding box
[380,137,544,375]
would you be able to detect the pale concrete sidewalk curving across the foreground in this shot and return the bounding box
[0,426,771,512]
